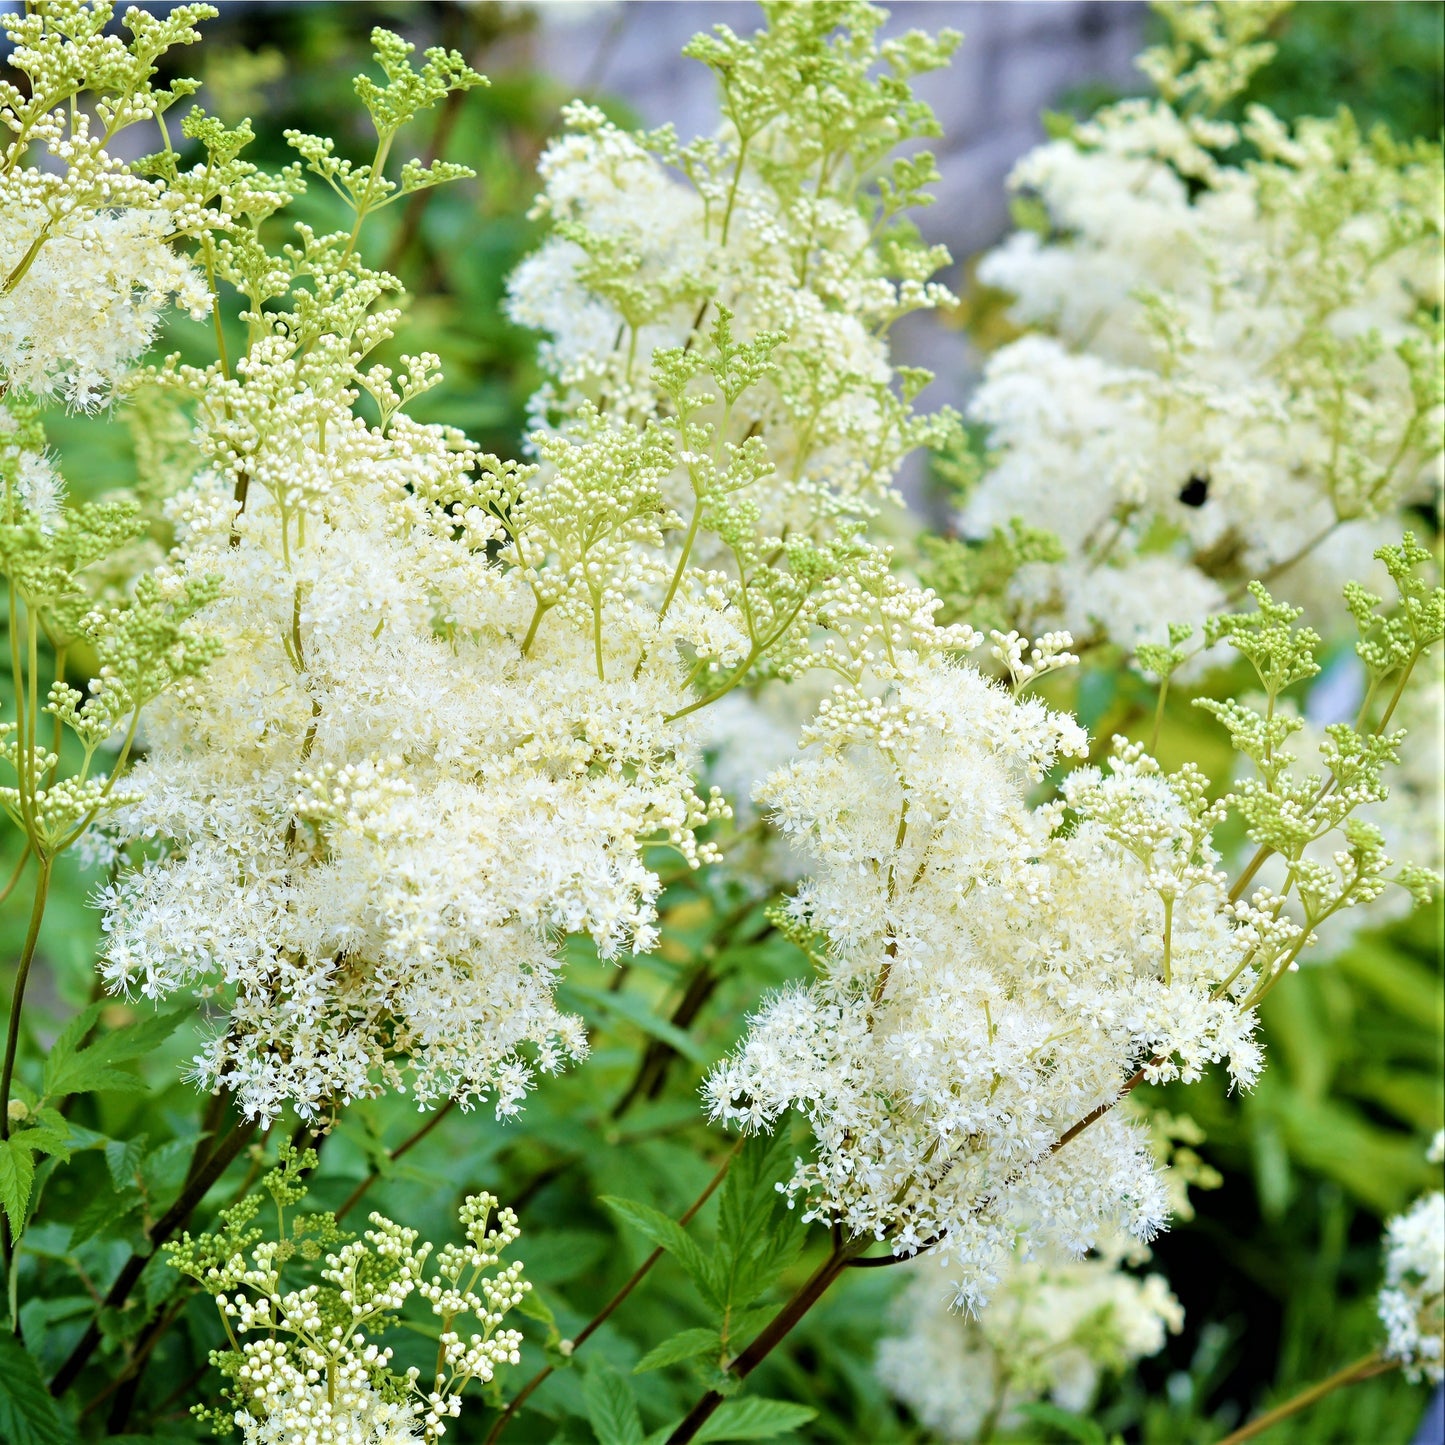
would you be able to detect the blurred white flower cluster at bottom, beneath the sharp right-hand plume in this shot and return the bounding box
[877,1236,1183,1442]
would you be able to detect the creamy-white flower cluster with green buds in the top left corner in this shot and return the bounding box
[0,0,215,407]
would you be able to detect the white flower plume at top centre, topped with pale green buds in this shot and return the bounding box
[509,4,958,536]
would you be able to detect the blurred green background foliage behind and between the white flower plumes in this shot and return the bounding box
[0,0,1445,1445]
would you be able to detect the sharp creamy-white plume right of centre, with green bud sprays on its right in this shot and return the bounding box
[705,535,1445,1309]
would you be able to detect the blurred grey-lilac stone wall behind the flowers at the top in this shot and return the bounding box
[533,0,1146,500]
